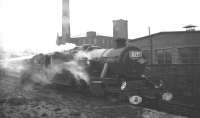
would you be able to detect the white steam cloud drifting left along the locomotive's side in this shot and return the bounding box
[0,42,89,93]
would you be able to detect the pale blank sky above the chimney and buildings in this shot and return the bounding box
[0,0,200,51]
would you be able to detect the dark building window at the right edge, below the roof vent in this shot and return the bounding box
[178,47,200,64]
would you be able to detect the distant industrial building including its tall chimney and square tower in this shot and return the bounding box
[56,0,128,48]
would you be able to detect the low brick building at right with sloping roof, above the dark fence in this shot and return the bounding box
[128,30,200,64]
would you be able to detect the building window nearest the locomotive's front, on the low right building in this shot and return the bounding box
[155,49,172,64]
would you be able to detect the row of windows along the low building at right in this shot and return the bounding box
[143,47,200,64]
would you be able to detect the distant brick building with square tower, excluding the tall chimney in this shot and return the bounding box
[71,19,128,48]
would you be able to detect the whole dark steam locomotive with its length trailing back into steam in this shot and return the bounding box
[21,45,173,105]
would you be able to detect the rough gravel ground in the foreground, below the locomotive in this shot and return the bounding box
[0,74,188,118]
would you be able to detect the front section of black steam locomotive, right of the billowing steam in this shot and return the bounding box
[77,47,172,104]
